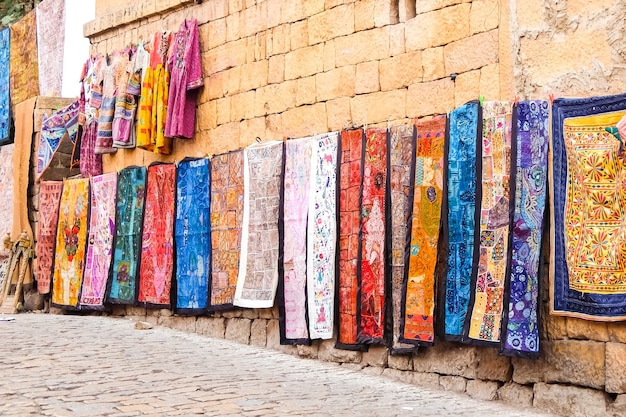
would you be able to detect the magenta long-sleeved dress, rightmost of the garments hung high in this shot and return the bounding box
[165,19,204,138]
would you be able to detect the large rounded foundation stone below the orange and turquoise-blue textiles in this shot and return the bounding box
[413,342,479,378]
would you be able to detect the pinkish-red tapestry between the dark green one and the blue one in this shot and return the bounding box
[139,164,176,307]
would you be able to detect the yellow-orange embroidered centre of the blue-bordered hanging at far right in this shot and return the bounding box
[563,111,626,294]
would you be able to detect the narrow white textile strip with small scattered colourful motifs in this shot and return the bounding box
[306,132,339,339]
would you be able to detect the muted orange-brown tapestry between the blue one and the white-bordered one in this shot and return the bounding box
[209,150,243,310]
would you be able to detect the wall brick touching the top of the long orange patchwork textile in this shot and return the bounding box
[406,78,454,117]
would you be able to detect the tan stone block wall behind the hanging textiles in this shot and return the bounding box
[80,0,626,416]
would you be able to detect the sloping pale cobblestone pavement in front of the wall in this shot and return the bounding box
[0,314,548,417]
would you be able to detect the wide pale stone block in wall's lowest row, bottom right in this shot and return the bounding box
[533,383,607,417]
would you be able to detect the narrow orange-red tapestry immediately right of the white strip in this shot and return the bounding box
[337,129,365,350]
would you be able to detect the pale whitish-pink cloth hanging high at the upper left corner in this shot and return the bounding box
[36,0,65,97]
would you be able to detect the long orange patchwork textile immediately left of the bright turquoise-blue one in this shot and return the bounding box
[399,116,446,346]
